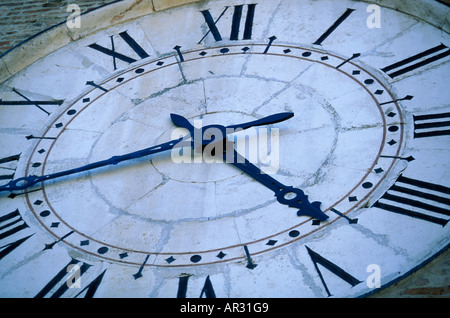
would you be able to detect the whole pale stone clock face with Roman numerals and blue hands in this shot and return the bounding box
[0,0,450,297]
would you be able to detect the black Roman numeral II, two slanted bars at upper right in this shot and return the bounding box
[381,43,450,78]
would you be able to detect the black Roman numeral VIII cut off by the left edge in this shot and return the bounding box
[0,210,33,260]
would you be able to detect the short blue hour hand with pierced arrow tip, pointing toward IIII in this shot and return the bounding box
[224,149,328,221]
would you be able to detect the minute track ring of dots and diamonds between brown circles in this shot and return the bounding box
[25,44,404,266]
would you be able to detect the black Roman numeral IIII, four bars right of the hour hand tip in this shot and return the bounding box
[373,175,450,226]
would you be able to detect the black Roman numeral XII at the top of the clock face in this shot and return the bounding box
[198,3,256,44]
